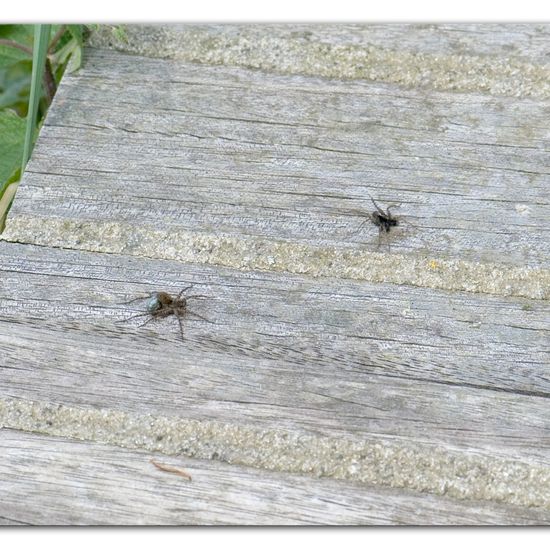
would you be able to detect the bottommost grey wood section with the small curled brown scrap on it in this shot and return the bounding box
[0,430,550,525]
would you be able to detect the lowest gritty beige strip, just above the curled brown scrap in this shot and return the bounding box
[0,399,550,508]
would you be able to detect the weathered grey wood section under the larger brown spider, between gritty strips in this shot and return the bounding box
[0,243,550,463]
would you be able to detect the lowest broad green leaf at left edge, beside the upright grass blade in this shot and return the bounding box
[0,110,25,192]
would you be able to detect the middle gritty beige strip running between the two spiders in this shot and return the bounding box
[2,216,550,300]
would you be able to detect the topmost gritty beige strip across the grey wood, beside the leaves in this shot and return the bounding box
[90,25,550,98]
